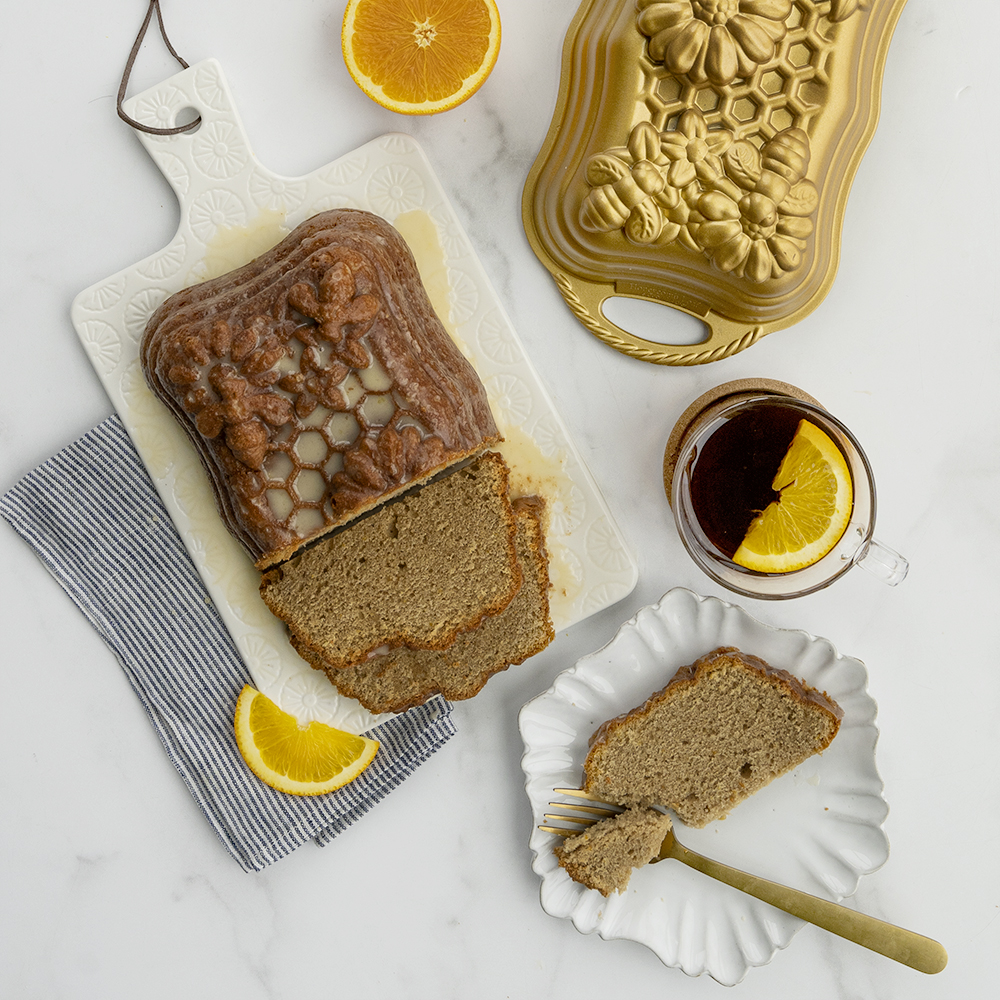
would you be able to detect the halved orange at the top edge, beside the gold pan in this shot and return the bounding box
[341,0,500,115]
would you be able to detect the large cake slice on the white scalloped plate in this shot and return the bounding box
[584,647,843,827]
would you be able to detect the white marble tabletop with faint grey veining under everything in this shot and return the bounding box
[0,0,1000,1000]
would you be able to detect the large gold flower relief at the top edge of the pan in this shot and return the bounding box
[636,0,792,86]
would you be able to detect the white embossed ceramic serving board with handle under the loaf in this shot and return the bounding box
[72,59,638,732]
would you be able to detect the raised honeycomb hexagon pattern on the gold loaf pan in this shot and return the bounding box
[639,0,839,146]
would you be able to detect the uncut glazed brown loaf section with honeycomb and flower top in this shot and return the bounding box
[141,209,500,568]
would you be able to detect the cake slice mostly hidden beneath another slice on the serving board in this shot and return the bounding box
[300,497,555,713]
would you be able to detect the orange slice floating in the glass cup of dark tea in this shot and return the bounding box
[733,420,854,573]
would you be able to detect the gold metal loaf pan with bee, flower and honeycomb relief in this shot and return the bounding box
[522,0,905,365]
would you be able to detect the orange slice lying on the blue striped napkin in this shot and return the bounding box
[235,684,379,795]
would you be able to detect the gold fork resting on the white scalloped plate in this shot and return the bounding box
[538,788,948,973]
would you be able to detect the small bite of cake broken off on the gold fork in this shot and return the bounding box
[555,808,671,896]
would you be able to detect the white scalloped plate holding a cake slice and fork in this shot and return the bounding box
[519,589,889,985]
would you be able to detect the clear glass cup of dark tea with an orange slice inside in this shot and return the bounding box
[664,382,907,598]
